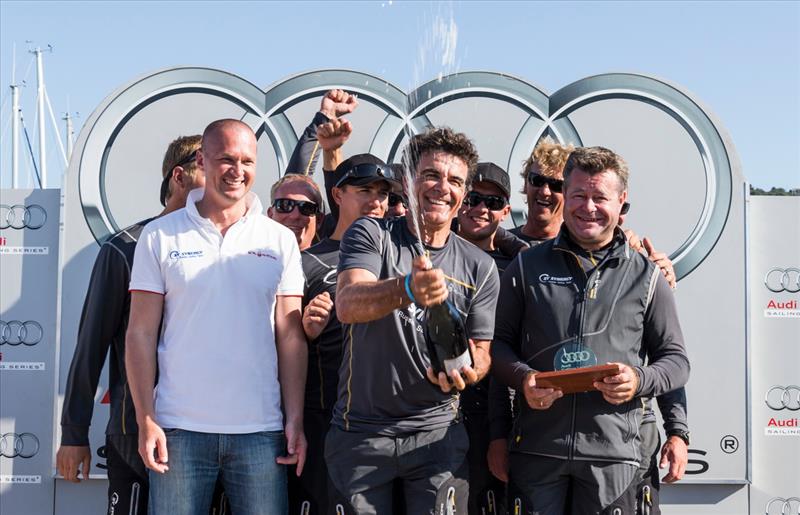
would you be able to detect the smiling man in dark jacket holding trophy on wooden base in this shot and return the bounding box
[493,147,689,514]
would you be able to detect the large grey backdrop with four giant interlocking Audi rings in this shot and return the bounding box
[59,67,746,481]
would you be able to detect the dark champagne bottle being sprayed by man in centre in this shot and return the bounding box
[424,300,473,377]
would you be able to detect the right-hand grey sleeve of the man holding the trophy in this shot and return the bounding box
[634,272,690,397]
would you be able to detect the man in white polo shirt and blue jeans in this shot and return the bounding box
[126,120,307,515]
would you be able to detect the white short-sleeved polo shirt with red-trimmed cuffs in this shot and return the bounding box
[130,189,304,433]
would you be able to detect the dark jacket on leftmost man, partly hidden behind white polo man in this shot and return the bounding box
[61,218,152,445]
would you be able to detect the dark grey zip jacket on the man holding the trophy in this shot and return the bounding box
[492,227,689,464]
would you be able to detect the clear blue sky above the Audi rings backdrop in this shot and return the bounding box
[0,0,800,188]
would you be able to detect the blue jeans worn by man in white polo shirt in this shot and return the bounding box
[149,429,288,515]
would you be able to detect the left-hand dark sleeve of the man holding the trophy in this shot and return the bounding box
[492,254,533,390]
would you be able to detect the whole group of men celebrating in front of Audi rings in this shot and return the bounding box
[57,90,689,515]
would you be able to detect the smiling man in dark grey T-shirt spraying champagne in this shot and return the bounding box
[325,128,498,514]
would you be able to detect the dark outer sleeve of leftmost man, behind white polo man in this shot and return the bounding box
[61,243,130,445]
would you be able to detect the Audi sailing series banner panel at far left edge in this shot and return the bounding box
[0,189,61,514]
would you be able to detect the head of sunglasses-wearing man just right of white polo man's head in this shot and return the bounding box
[267,174,323,250]
